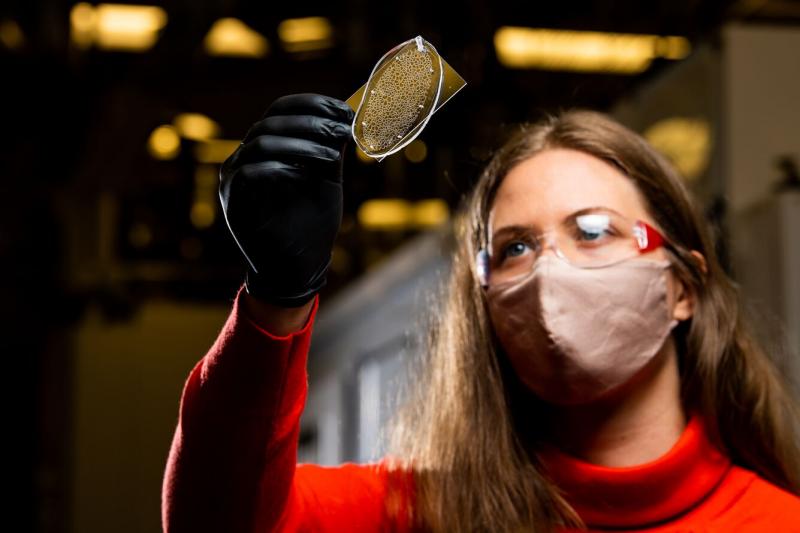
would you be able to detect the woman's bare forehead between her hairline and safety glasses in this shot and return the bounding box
[490,148,650,229]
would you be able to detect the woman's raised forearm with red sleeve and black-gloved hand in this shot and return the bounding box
[163,94,353,533]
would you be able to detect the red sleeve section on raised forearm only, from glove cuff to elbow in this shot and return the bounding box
[162,289,318,533]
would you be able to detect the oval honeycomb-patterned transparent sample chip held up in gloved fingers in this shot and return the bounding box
[347,36,466,161]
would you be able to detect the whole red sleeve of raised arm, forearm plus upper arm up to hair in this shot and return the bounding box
[162,284,413,533]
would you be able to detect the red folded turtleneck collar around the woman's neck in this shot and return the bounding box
[538,415,731,527]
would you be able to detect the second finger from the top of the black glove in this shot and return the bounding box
[239,115,351,144]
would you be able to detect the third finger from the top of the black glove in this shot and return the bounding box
[236,135,341,165]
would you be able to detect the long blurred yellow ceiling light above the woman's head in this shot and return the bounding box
[494,26,691,74]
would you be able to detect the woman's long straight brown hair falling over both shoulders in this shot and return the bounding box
[392,111,800,532]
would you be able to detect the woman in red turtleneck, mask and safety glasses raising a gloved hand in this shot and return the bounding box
[163,95,800,532]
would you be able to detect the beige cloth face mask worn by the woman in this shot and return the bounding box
[487,255,678,405]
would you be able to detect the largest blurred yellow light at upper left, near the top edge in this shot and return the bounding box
[70,2,167,52]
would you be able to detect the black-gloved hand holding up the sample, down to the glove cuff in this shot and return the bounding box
[219,94,354,307]
